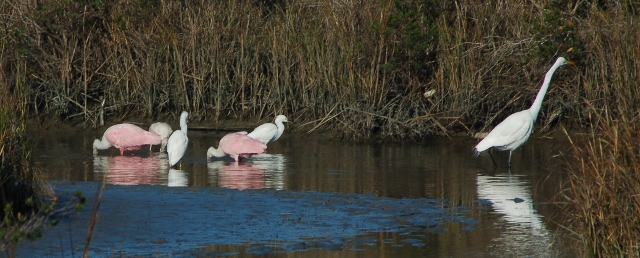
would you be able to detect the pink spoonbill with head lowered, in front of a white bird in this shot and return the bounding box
[207,132,267,162]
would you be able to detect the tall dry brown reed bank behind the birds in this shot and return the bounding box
[0,0,640,138]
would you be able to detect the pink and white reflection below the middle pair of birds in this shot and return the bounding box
[207,154,285,190]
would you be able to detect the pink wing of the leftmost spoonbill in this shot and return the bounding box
[105,124,162,148]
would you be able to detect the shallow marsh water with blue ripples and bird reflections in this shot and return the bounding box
[18,127,569,257]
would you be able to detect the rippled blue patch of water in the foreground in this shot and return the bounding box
[20,182,475,255]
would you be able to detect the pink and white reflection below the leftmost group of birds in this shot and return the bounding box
[93,153,186,185]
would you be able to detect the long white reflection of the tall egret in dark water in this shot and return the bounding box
[477,174,552,255]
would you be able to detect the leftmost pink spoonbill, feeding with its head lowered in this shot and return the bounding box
[93,124,162,155]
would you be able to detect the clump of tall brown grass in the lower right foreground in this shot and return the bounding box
[565,110,640,257]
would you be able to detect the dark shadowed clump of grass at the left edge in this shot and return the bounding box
[0,77,84,257]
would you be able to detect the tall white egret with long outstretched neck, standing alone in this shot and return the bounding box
[474,57,573,167]
